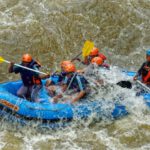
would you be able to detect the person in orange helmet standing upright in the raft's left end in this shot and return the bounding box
[9,54,49,101]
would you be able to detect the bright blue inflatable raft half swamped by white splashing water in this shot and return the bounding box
[0,72,150,125]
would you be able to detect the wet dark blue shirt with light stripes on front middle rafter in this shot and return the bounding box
[63,73,88,92]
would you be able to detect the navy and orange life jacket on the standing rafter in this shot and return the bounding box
[20,60,42,86]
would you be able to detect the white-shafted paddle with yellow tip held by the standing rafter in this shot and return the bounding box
[0,56,47,75]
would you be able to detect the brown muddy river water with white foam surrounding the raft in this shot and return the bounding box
[0,0,150,150]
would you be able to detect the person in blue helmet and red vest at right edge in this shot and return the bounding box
[133,49,150,86]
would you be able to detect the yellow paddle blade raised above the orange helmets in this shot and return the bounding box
[82,41,94,58]
